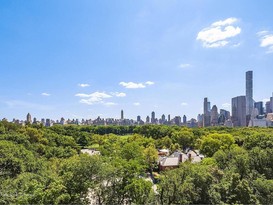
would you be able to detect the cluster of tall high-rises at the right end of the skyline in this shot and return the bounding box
[198,71,273,127]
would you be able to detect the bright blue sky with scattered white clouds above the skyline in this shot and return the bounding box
[0,0,273,120]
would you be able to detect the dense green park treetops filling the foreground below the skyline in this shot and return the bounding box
[0,121,273,204]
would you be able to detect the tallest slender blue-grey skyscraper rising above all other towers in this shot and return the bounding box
[246,71,254,116]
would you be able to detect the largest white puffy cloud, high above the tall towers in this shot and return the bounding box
[196,18,241,48]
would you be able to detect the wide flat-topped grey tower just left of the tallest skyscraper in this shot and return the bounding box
[231,96,247,127]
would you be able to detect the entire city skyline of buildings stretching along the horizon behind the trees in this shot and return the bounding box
[3,71,273,127]
